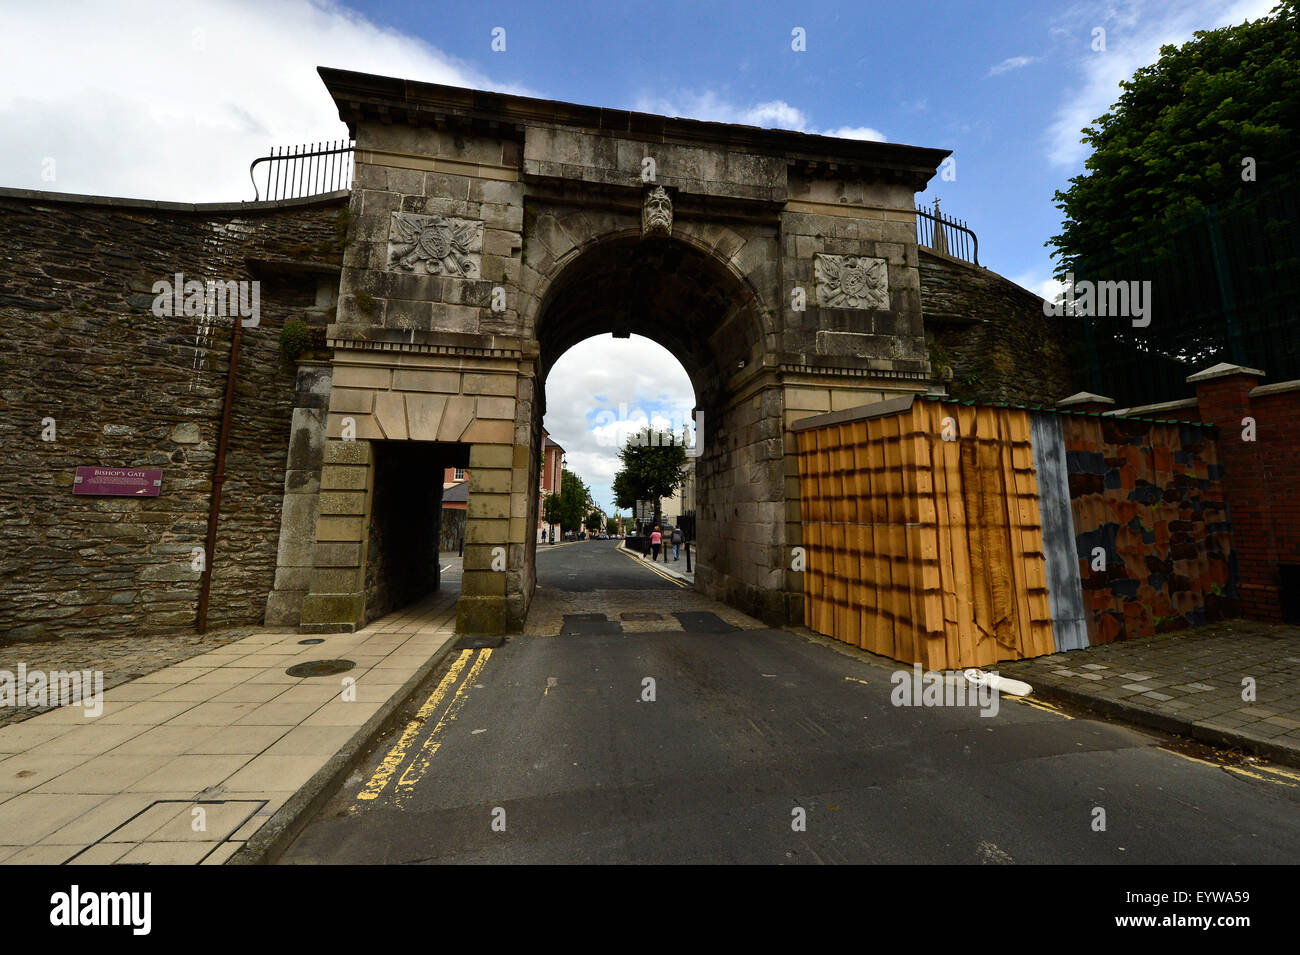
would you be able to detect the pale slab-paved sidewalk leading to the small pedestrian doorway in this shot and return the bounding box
[0,589,458,864]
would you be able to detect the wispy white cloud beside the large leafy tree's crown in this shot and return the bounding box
[1048,0,1277,166]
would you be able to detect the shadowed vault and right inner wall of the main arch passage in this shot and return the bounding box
[533,231,785,616]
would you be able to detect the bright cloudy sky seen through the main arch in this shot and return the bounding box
[542,335,707,513]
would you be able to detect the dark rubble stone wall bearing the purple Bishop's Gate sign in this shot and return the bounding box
[0,190,347,639]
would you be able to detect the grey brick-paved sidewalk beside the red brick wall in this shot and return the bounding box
[997,620,1300,765]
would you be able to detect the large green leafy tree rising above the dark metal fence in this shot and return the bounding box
[1048,0,1300,278]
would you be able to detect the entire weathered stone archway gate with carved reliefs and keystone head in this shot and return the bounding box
[292,68,948,633]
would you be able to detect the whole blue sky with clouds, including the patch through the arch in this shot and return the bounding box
[0,0,1273,514]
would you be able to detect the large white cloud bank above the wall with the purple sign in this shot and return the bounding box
[0,0,522,201]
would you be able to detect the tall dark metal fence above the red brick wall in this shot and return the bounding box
[1076,168,1300,405]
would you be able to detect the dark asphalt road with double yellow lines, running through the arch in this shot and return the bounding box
[281,542,1300,864]
